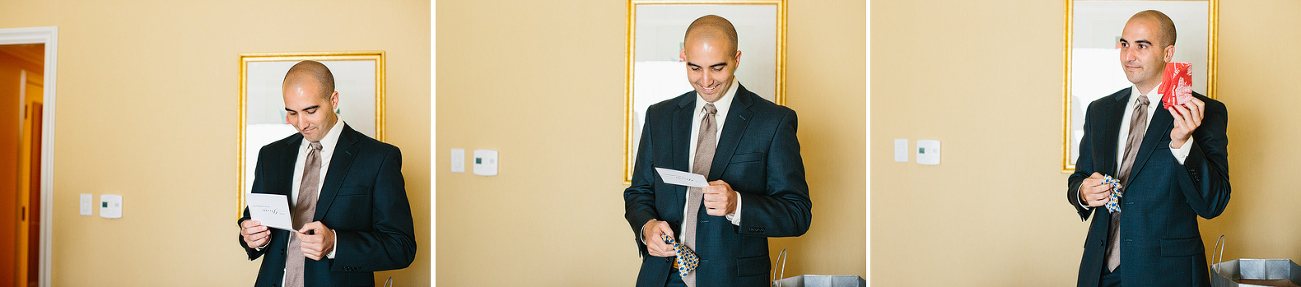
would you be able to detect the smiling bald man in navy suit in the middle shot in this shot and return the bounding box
[623,16,813,287]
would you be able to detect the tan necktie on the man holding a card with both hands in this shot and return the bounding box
[285,143,321,287]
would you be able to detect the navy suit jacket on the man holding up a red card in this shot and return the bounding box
[1067,87,1229,287]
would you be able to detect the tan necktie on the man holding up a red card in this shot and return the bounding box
[1105,95,1147,271]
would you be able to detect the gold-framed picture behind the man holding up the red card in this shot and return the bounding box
[1062,0,1219,173]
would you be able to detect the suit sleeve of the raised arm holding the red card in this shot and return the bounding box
[1175,96,1231,219]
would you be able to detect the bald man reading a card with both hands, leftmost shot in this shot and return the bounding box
[237,61,416,287]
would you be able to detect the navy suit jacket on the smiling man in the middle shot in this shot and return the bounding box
[623,84,813,287]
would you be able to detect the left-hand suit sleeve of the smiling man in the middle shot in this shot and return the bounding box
[623,119,658,257]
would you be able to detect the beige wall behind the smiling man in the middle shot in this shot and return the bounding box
[435,0,866,286]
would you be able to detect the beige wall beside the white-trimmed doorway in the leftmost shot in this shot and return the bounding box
[0,0,433,286]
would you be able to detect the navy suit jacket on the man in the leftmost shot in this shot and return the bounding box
[237,122,415,286]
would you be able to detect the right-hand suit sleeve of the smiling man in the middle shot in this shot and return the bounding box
[736,109,813,236]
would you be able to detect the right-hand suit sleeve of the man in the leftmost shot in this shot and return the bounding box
[330,148,416,271]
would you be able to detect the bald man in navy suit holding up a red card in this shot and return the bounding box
[1067,10,1229,287]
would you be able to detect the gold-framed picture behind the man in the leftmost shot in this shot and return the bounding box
[237,51,385,217]
